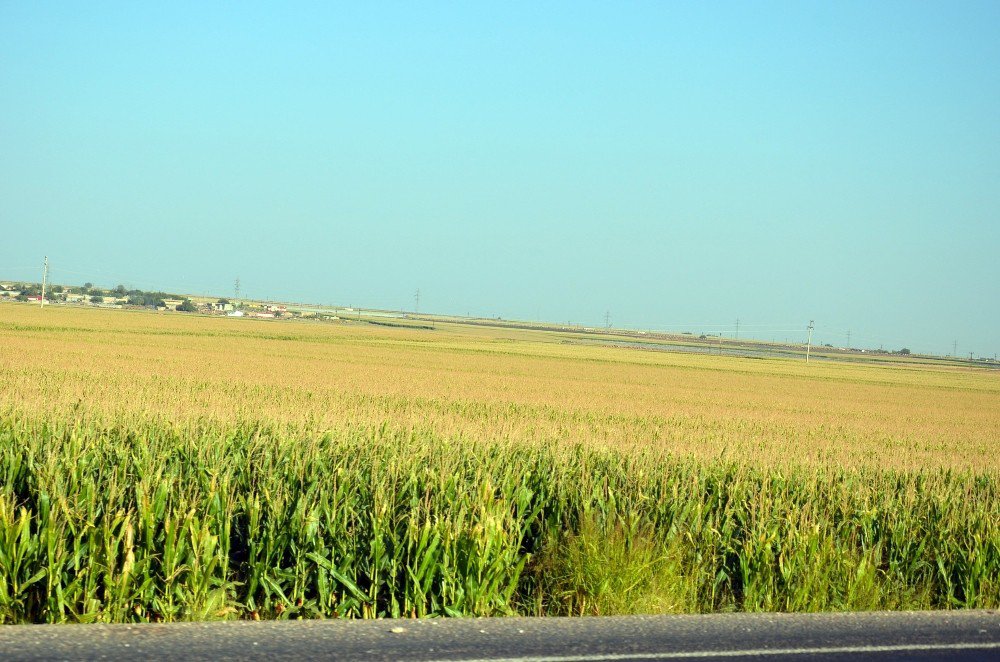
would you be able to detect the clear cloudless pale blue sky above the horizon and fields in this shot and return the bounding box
[0,0,1000,356]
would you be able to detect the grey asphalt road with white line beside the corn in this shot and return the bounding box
[0,611,1000,662]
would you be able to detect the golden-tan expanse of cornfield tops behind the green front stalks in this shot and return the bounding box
[0,305,1000,470]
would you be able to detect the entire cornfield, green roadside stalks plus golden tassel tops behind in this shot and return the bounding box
[0,304,1000,623]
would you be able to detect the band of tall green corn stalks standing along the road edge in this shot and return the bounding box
[0,410,1000,623]
